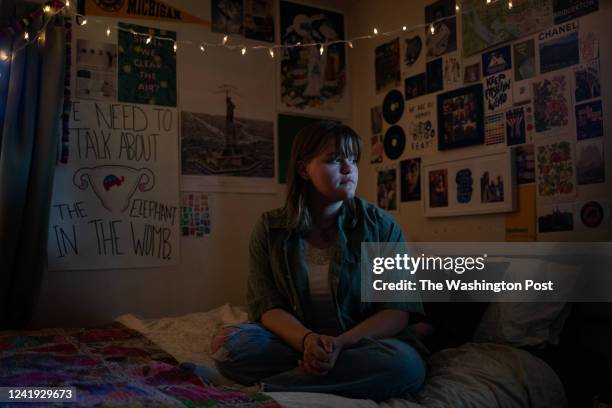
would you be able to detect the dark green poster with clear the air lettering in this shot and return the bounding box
[118,23,176,106]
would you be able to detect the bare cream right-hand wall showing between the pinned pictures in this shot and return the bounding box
[347,0,612,242]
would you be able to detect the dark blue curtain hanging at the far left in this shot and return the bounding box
[0,0,66,329]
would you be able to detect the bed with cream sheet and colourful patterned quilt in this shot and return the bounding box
[0,305,567,408]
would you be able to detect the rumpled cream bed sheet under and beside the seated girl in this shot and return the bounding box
[117,304,567,408]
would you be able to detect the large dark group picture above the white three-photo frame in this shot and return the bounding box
[438,84,484,150]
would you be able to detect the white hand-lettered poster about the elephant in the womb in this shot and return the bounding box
[48,101,181,270]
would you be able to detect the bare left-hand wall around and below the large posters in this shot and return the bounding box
[31,0,348,328]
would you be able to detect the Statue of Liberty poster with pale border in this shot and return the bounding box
[178,30,277,193]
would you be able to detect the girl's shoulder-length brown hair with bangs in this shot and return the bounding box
[285,121,362,233]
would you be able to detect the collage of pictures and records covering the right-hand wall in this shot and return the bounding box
[371,0,610,236]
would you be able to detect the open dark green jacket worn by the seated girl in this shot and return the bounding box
[247,198,424,334]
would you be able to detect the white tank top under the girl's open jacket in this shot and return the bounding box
[304,241,340,335]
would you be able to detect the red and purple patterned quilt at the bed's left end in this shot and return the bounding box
[0,322,279,408]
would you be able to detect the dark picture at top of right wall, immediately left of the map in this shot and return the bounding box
[425,0,457,59]
